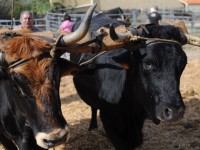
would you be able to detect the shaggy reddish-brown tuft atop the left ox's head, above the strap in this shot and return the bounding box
[0,34,52,61]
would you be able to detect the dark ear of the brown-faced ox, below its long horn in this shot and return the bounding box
[58,58,80,76]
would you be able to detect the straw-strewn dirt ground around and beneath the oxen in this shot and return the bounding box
[0,45,200,150]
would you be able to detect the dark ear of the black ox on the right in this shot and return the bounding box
[112,53,130,70]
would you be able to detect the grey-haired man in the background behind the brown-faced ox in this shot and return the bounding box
[13,10,40,32]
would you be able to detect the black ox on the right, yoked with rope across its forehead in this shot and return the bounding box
[71,14,187,150]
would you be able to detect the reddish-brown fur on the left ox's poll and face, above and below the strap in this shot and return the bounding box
[0,32,52,110]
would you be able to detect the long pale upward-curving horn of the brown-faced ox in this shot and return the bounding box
[62,4,97,45]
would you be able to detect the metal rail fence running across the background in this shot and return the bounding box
[0,10,200,32]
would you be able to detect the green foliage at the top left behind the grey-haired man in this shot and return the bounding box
[0,0,50,19]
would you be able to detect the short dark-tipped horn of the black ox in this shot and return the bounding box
[109,24,131,42]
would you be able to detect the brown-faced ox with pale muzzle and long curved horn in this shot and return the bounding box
[0,5,101,150]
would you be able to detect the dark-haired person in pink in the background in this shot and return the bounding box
[60,14,74,32]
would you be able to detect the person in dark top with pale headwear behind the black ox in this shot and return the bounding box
[147,6,162,25]
